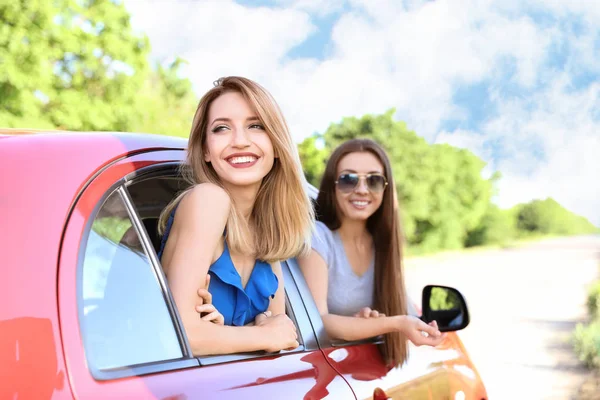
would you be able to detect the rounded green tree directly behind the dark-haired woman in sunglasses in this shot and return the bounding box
[300,109,492,251]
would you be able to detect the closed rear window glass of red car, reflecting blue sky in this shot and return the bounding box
[78,190,183,370]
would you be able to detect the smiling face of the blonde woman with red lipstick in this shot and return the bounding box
[204,92,275,190]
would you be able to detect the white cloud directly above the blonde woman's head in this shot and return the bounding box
[125,0,315,93]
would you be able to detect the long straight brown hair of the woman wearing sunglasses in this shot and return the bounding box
[315,139,408,366]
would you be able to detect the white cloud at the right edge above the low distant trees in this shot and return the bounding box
[436,75,600,225]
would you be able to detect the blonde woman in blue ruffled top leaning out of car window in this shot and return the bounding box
[159,77,314,356]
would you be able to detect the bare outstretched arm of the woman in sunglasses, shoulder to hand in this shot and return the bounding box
[298,250,440,345]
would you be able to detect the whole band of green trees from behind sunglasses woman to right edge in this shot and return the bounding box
[299,109,596,252]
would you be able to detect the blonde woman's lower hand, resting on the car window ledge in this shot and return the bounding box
[254,311,300,353]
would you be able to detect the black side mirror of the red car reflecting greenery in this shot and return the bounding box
[421,285,469,332]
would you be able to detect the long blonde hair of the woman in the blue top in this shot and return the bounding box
[159,76,314,262]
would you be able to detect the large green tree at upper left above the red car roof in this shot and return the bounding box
[0,0,149,131]
